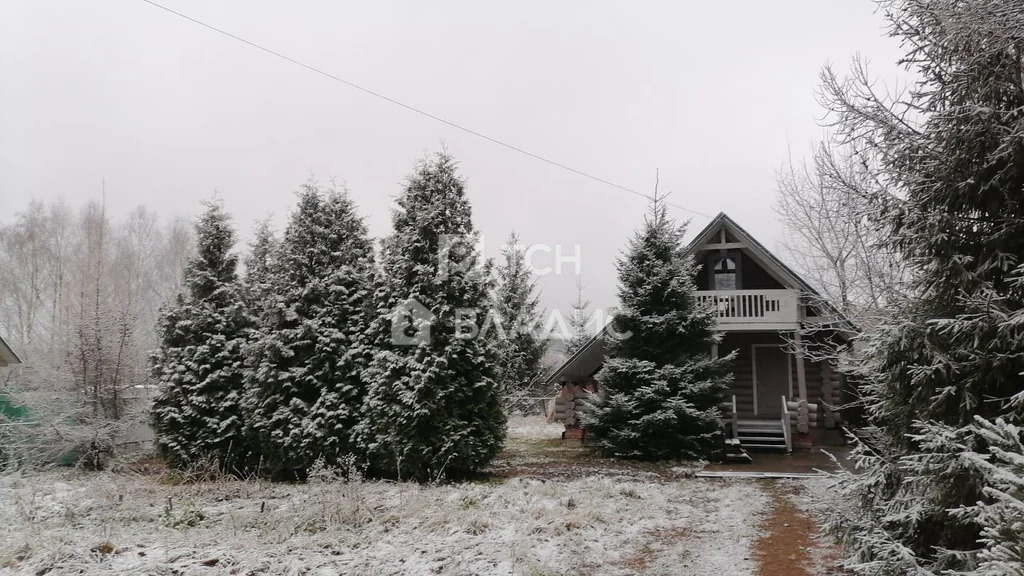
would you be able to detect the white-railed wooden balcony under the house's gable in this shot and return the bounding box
[695,290,800,330]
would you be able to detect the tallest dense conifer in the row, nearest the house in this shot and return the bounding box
[358,152,506,481]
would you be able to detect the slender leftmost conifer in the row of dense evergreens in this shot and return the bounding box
[150,202,253,474]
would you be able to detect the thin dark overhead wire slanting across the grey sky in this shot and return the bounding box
[134,0,712,218]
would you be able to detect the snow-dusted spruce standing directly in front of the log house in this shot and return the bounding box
[583,194,732,460]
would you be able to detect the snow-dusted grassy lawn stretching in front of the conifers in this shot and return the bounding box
[0,414,767,576]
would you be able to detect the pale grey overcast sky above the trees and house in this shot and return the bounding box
[0,0,899,310]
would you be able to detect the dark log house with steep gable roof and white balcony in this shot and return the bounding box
[549,213,856,450]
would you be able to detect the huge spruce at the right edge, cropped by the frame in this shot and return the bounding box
[824,0,1024,575]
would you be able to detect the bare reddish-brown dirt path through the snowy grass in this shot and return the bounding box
[754,481,844,576]
